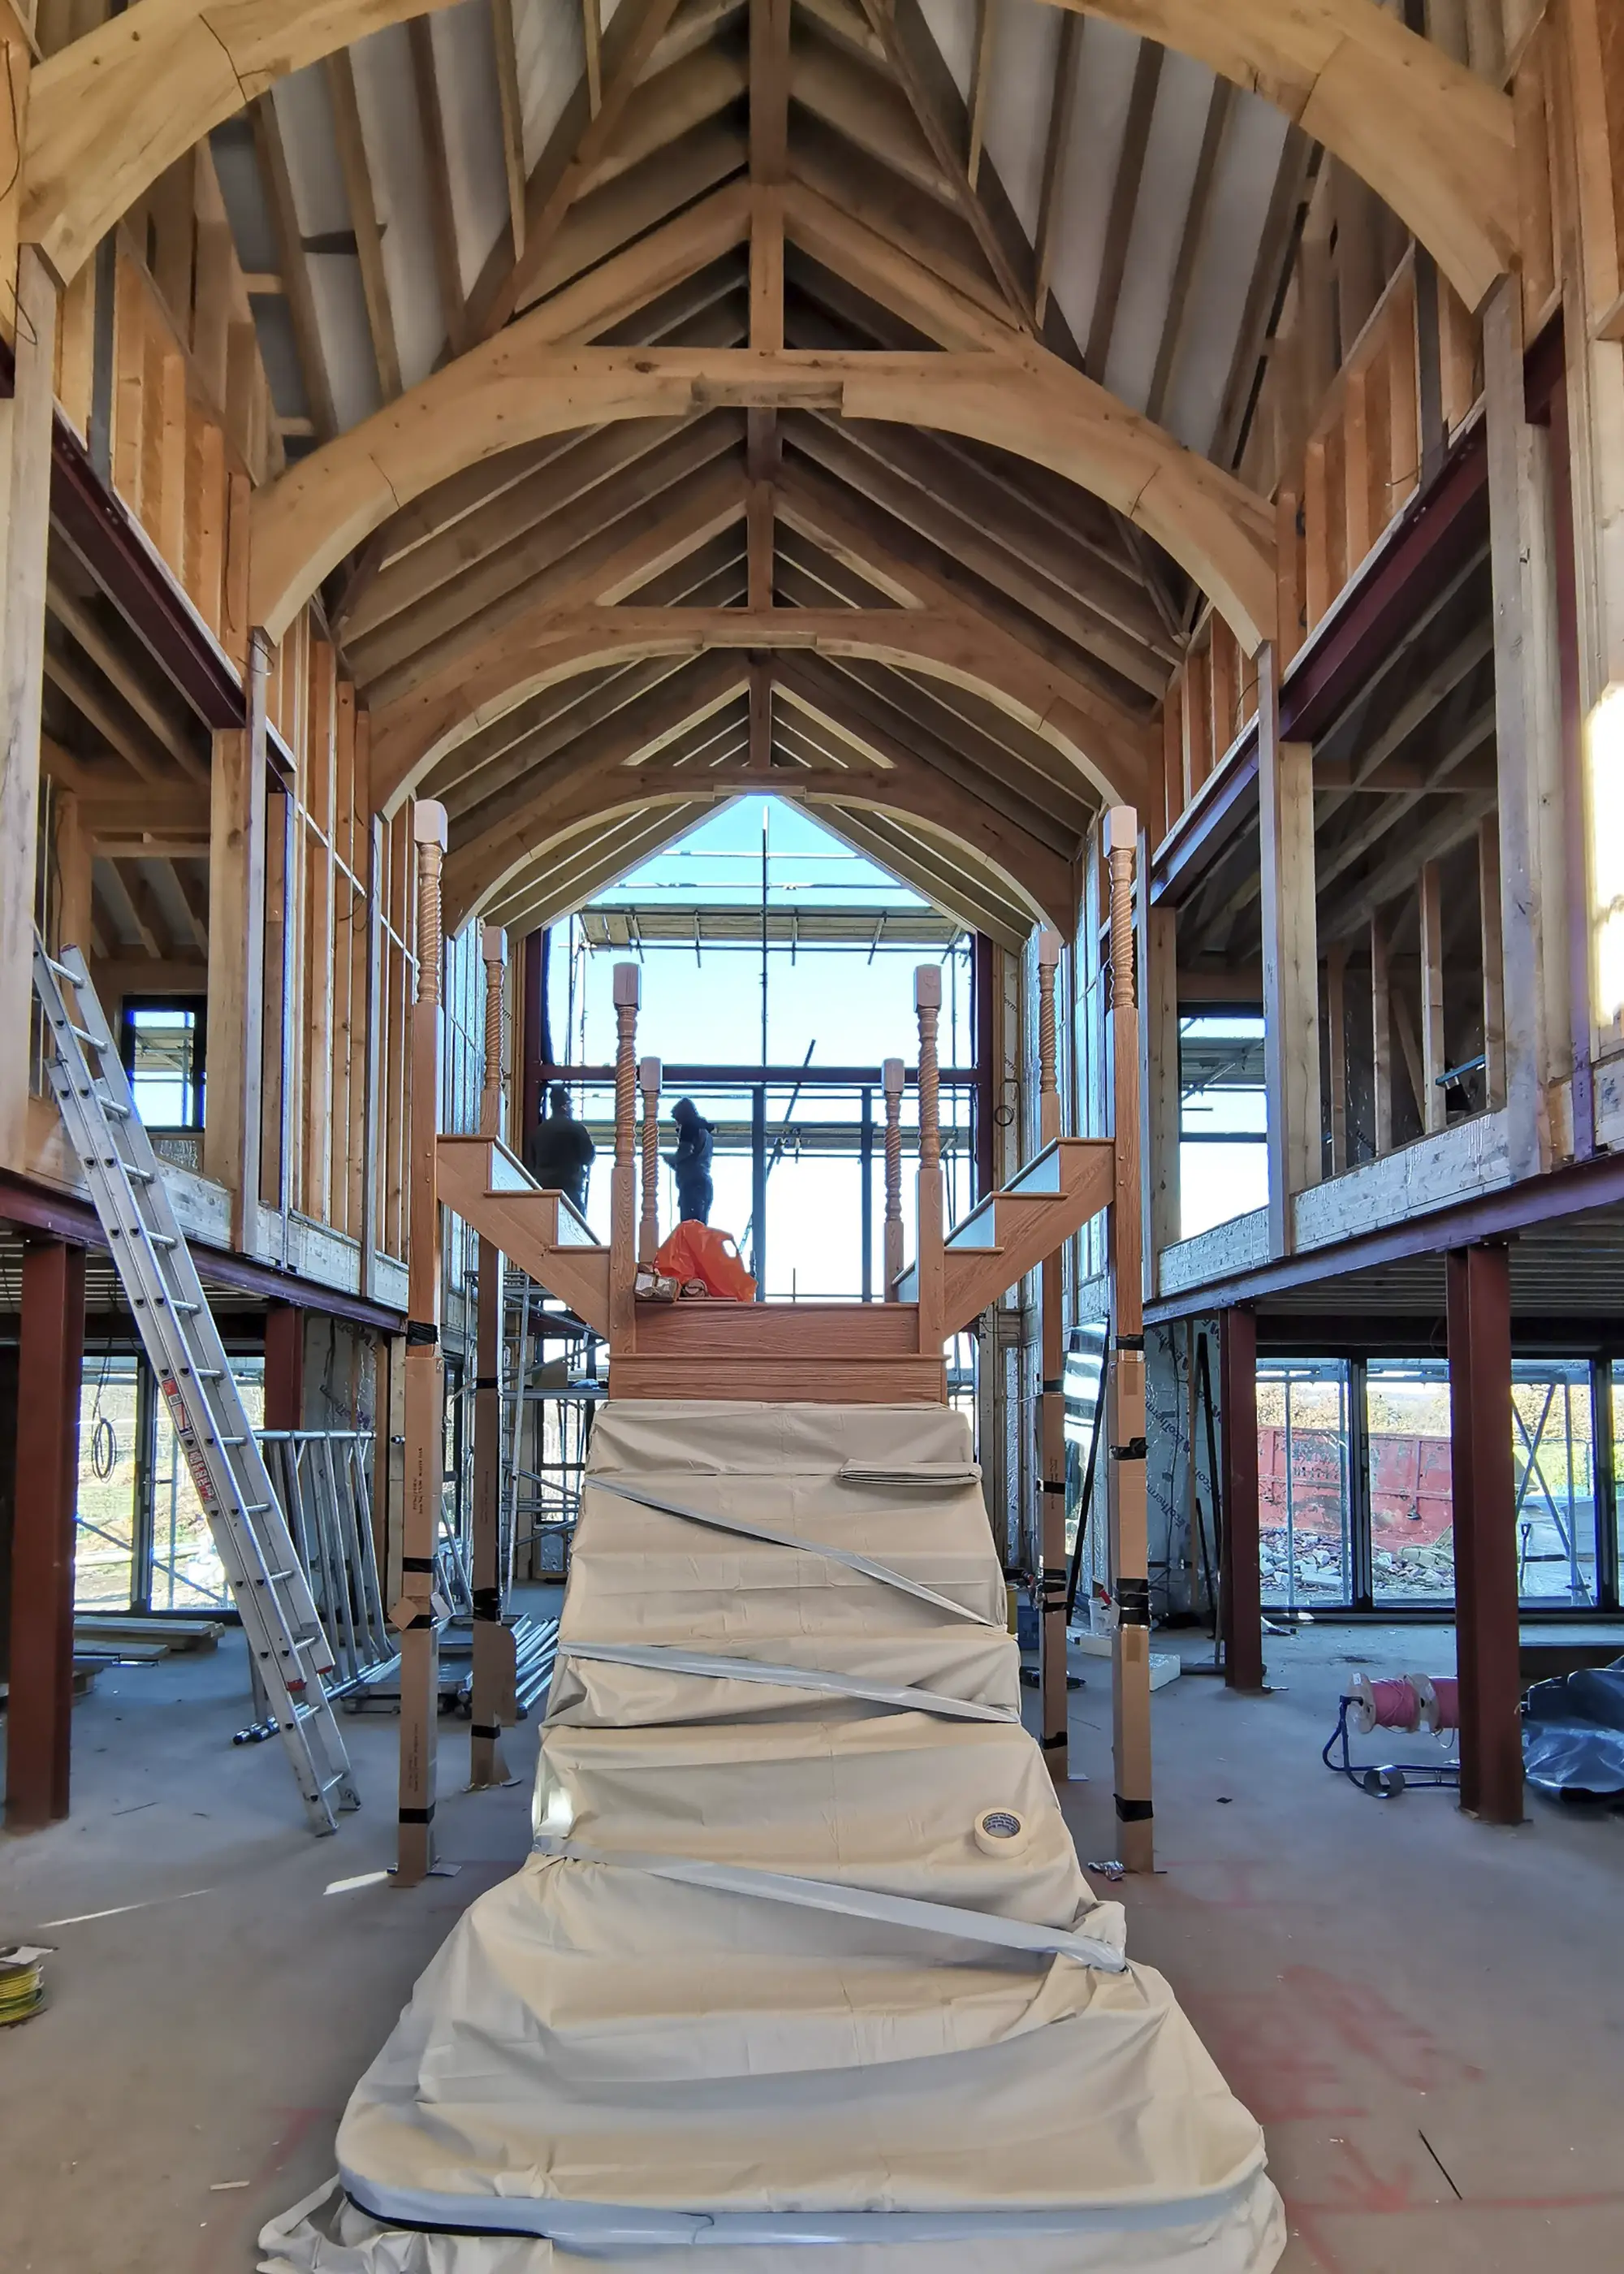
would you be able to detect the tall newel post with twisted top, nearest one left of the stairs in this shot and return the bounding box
[391,798,446,1887]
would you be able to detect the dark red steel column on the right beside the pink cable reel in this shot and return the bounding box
[1449,1246,1522,1824]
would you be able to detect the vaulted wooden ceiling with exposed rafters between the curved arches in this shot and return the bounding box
[214,0,1317,941]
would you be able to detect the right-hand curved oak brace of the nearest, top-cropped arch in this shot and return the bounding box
[1051,0,1519,307]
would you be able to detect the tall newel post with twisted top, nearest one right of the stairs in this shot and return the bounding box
[1105,805,1155,1871]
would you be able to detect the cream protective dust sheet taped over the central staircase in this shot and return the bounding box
[261,1401,1285,2274]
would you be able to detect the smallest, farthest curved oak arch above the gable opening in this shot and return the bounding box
[446,767,1055,937]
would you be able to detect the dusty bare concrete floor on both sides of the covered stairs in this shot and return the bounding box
[0,1626,1624,2274]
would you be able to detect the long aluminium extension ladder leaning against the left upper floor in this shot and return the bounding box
[34,935,360,1833]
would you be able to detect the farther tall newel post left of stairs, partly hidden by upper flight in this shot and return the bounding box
[469,923,519,1792]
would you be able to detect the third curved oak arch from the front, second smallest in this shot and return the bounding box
[371,605,1151,814]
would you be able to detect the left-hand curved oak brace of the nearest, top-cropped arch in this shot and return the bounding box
[20,0,455,284]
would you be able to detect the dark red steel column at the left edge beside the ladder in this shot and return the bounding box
[5,1239,84,1833]
